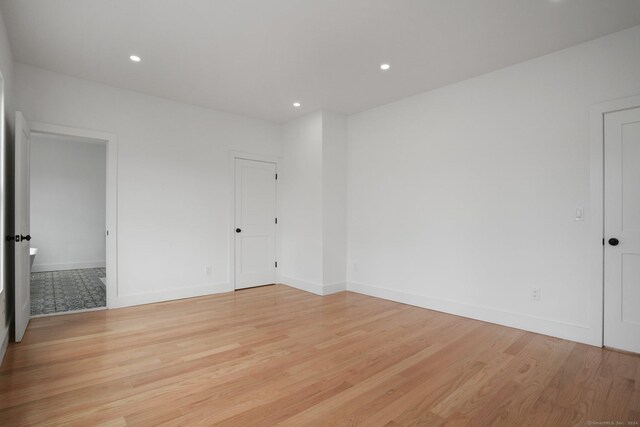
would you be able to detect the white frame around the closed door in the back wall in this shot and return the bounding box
[227,150,282,291]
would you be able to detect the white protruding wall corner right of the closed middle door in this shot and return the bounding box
[278,111,346,295]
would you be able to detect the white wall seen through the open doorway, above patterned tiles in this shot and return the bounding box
[31,134,107,271]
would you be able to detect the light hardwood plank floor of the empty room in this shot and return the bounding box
[0,286,640,426]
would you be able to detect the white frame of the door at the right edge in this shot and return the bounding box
[589,95,640,347]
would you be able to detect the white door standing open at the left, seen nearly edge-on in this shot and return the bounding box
[14,111,31,342]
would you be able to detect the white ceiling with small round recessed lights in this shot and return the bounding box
[0,0,640,122]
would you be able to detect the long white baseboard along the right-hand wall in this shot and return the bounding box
[347,282,600,347]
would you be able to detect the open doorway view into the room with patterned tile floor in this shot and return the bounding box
[29,134,107,317]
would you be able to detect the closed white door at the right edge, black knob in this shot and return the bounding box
[604,108,640,353]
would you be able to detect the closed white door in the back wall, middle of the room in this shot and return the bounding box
[235,159,276,289]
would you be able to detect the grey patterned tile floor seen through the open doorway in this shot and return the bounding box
[31,268,106,316]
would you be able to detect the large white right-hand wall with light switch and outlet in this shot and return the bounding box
[348,27,640,344]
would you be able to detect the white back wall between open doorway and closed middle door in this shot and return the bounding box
[15,64,281,306]
